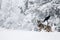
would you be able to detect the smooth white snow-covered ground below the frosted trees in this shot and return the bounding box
[0,29,60,40]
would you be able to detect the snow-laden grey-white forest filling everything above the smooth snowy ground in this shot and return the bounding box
[0,0,60,32]
